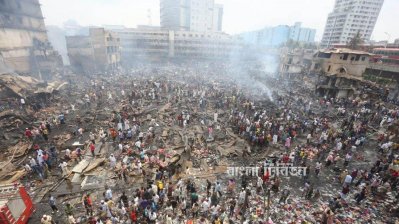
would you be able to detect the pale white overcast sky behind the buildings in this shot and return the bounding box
[40,0,399,42]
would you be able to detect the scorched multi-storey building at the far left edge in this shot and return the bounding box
[0,0,62,78]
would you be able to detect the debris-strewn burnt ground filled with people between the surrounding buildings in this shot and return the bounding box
[0,63,399,223]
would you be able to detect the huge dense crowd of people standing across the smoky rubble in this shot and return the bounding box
[11,62,399,224]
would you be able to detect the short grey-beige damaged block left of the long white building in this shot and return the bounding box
[66,28,121,74]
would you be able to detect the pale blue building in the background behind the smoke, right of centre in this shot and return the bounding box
[239,22,316,47]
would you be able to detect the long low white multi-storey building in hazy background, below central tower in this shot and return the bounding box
[113,27,240,66]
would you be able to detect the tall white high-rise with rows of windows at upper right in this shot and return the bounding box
[321,0,384,47]
